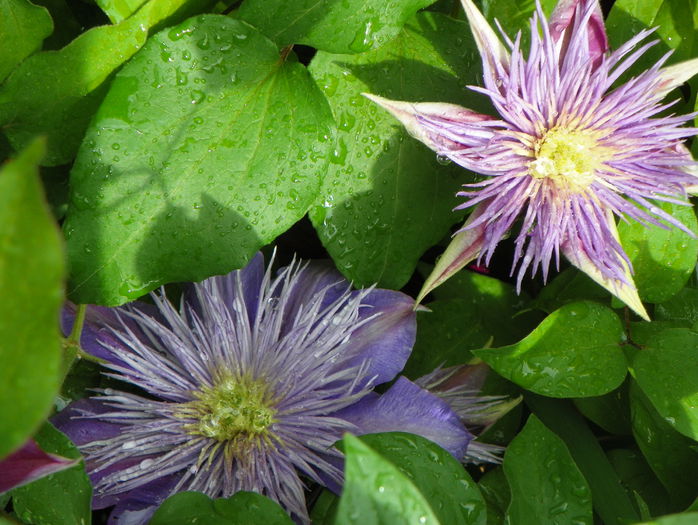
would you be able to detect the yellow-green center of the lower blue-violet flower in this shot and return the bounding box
[181,377,276,441]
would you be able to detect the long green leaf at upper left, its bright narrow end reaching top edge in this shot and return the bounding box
[0,0,215,166]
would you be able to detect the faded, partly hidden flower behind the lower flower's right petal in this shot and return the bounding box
[415,363,522,464]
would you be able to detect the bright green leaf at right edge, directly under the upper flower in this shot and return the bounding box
[618,203,698,303]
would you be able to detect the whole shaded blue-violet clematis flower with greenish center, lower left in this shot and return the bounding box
[54,255,471,525]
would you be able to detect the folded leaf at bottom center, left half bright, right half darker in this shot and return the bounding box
[335,432,485,525]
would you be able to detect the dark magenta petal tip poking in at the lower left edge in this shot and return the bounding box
[0,439,80,493]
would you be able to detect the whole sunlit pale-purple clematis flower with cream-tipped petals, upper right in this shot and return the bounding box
[366,0,698,319]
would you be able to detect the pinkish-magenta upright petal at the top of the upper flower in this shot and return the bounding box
[549,0,608,64]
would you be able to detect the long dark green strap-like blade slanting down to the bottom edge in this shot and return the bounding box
[525,393,640,525]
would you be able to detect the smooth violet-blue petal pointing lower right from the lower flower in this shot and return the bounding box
[336,376,472,460]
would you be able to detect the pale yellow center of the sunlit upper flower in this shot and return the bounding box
[528,128,603,191]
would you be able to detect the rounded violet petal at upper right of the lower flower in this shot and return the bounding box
[341,289,417,385]
